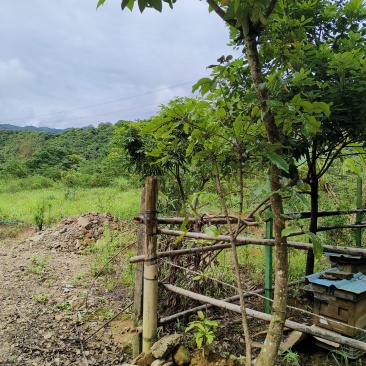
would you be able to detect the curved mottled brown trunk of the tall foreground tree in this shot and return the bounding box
[244,34,288,366]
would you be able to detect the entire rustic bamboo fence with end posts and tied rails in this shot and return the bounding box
[130,177,366,355]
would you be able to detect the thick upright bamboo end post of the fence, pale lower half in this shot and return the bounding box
[142,177,158,352]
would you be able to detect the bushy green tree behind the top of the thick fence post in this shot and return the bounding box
[111,98,210,210]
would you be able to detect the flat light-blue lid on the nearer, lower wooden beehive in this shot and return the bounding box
[305,268,366,294]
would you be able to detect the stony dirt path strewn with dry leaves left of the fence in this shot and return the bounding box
[0,220,132,365]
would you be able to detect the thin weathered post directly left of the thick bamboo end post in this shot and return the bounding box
[132,187,146,358]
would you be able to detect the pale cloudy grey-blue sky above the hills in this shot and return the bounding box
[0,0,234,128]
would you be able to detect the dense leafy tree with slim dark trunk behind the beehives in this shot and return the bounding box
[256,0,366,274]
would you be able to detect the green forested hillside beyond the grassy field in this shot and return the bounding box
[0,123,121,186]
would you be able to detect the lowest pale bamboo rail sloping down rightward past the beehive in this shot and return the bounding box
[162,284,366,352]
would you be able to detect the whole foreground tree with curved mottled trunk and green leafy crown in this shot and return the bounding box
[98,0,364,366]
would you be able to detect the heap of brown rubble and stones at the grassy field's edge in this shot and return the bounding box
[27,212,127,253]
